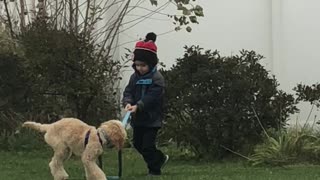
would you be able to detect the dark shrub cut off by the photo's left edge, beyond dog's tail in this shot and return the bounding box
[0,53,28,132]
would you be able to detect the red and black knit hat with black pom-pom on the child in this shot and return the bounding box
[133,32,158,69]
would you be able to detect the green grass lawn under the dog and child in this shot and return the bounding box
[0,149,320,180]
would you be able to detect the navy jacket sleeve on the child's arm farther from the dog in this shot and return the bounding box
[137,73,164,111]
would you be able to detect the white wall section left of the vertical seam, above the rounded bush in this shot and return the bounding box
[122,0,272,69]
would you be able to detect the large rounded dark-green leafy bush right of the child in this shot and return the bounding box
[163,46,297,158]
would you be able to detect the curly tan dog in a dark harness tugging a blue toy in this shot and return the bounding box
[23,118,127,180]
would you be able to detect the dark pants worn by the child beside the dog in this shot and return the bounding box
[133,127,165,174]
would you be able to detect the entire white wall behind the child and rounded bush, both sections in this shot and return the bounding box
[120,0,320,123]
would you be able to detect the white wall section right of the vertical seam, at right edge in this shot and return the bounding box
[273,0,320,123]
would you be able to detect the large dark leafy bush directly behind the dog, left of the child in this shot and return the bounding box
[19,20,121,124]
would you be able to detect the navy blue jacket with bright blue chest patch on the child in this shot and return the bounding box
[122,69,164,127]
